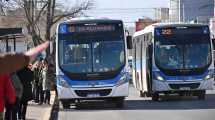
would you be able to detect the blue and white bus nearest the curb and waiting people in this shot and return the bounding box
[56,18,131,108]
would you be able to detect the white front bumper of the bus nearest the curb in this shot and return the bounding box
[57,82,129,100]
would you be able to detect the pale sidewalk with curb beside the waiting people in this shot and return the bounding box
[26,91,55,120]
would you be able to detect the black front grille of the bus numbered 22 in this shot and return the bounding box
[169,83,200,89]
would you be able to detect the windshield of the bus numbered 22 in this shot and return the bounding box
[155,34,212,70]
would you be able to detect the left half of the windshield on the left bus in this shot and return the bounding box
[60,42,92,73]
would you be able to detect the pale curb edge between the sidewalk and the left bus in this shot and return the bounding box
[42,91,56,120]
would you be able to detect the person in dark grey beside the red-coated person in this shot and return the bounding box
[4,73,23,120]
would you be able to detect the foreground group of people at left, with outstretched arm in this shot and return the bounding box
[0,42,50,120]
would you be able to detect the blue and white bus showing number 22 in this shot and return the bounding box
[133,23,214,101]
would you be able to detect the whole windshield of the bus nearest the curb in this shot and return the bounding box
[59,40,125,73]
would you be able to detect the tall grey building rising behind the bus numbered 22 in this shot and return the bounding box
[169,0,214,23]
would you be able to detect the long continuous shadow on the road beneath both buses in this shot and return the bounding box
[59,94,215,112]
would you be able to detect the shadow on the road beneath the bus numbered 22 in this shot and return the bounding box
[124,94,215,110]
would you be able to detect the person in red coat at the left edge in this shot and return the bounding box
[0,75,16,120]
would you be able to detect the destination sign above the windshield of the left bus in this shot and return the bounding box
[68,25,115,33]
